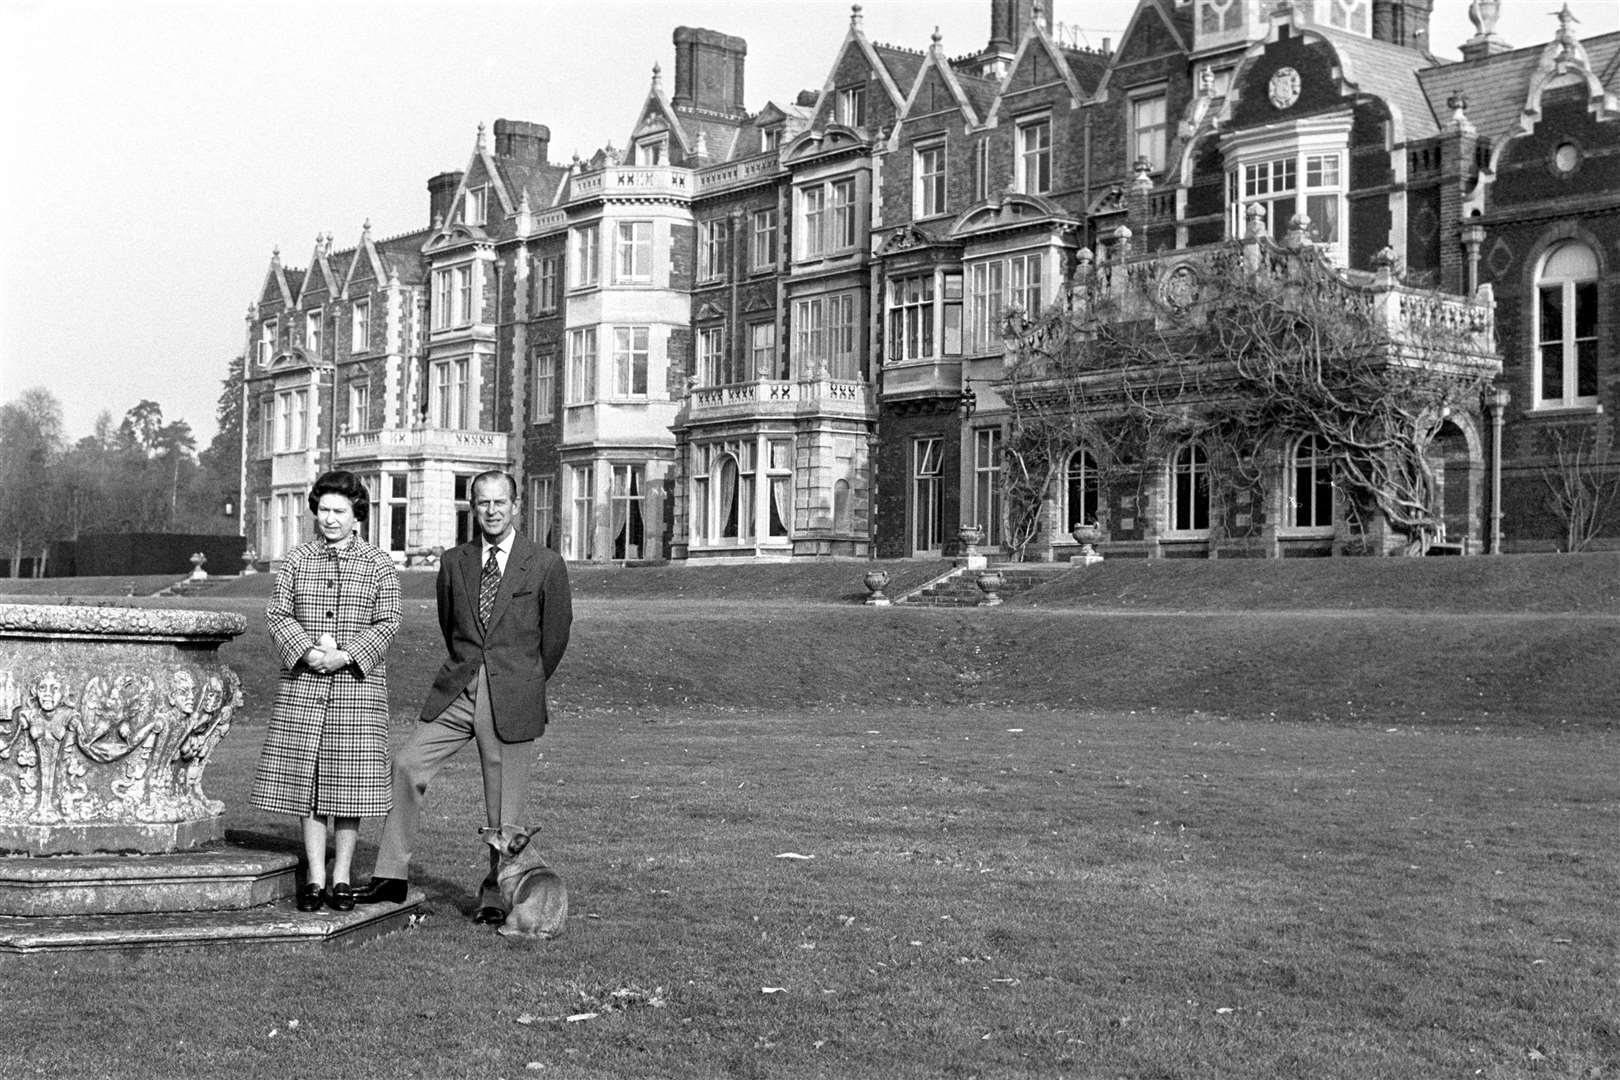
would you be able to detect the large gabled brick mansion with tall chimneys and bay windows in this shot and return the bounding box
[241,0,1620,560]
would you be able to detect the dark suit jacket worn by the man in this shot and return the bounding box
[421,534,573,743]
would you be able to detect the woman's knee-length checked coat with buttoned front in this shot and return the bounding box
[253,536,400,818]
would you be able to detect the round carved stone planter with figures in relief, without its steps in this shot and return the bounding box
[0,604,246,855]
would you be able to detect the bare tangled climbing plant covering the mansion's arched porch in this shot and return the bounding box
[1001,232,1499,554]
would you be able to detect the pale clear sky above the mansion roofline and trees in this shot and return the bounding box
[0,0,1620,449]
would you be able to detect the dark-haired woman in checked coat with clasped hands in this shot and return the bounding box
[253,470,400,912]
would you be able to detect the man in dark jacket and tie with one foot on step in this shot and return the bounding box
[355,471,573,926]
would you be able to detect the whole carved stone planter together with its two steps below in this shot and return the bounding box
[0,604,421,952]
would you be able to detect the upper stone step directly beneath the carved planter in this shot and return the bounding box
[0,848,298,918]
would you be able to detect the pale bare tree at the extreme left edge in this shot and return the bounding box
[0,387,62,576]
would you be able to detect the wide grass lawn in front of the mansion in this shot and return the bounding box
[0,557,1620,1080]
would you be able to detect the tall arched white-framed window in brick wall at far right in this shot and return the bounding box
[1534,243,1597,408]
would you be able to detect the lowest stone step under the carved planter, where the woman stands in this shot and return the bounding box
[0,891,426,952]
